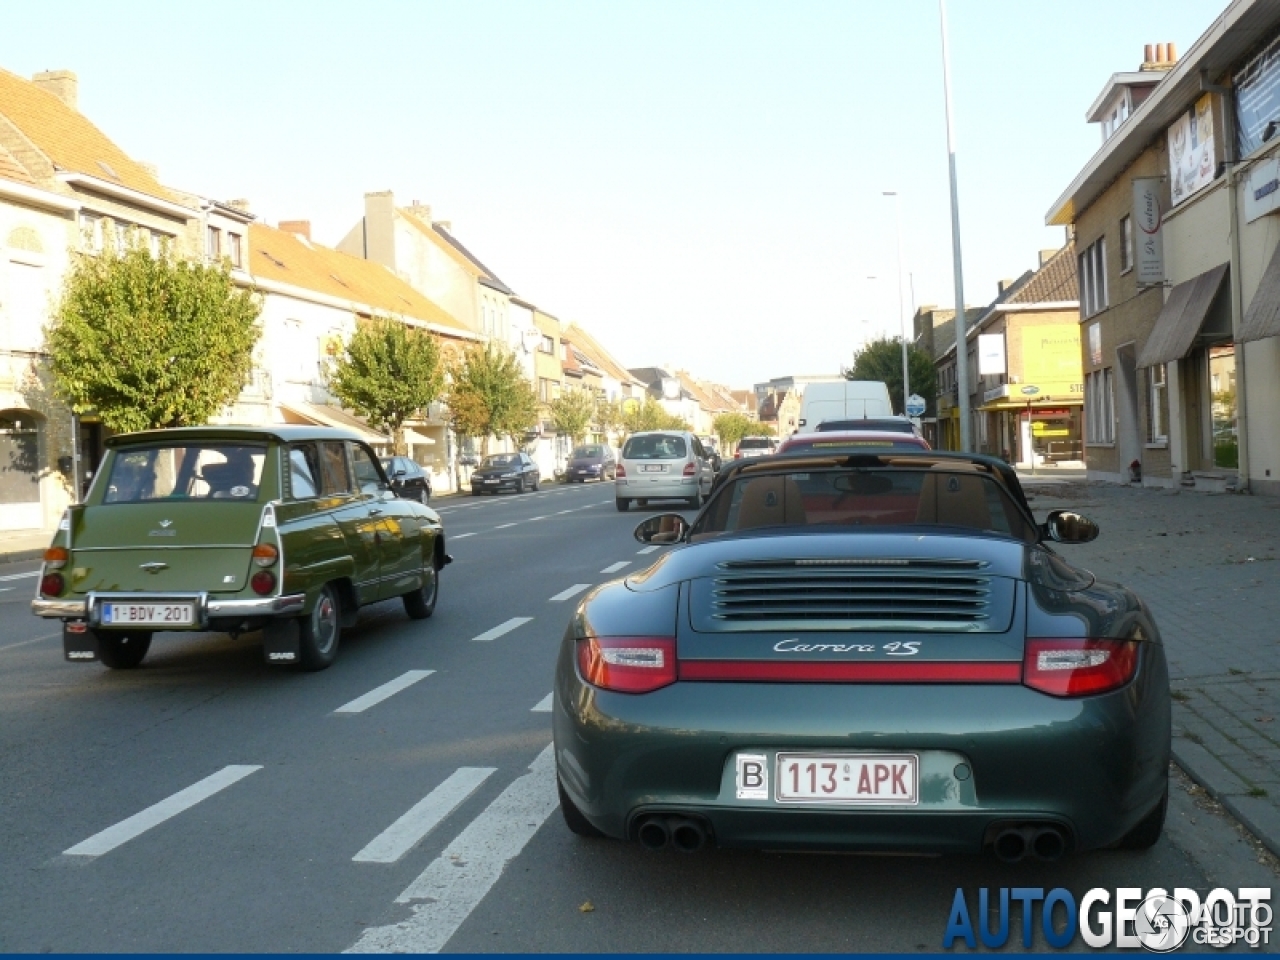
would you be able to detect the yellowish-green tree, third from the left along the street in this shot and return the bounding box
[448,343,538,453]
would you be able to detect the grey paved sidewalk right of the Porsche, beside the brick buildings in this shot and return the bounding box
[1025,476,1280,855]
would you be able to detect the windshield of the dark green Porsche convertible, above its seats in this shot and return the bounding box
[690,461,1037,543]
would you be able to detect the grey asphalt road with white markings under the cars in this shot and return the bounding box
[0,484,1276,952]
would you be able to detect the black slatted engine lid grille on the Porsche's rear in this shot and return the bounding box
[691,558,1012,632]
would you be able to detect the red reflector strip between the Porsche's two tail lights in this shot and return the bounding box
[678,660,1023,684]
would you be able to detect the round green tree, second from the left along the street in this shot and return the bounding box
[329,316,444,454]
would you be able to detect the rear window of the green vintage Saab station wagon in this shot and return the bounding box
[102,443,266,503]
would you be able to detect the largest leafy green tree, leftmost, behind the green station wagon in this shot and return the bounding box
[45,243,262,431]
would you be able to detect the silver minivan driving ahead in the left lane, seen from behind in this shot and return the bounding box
[614,430,716,511]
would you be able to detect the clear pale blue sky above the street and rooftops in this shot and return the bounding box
[0,0,1225,387]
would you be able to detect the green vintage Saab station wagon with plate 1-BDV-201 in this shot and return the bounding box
[32,425,451,669]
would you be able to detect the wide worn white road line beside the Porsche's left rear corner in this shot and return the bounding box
[347,745,559,954]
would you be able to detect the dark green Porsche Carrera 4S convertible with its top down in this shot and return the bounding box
[553,449,1170,860]
